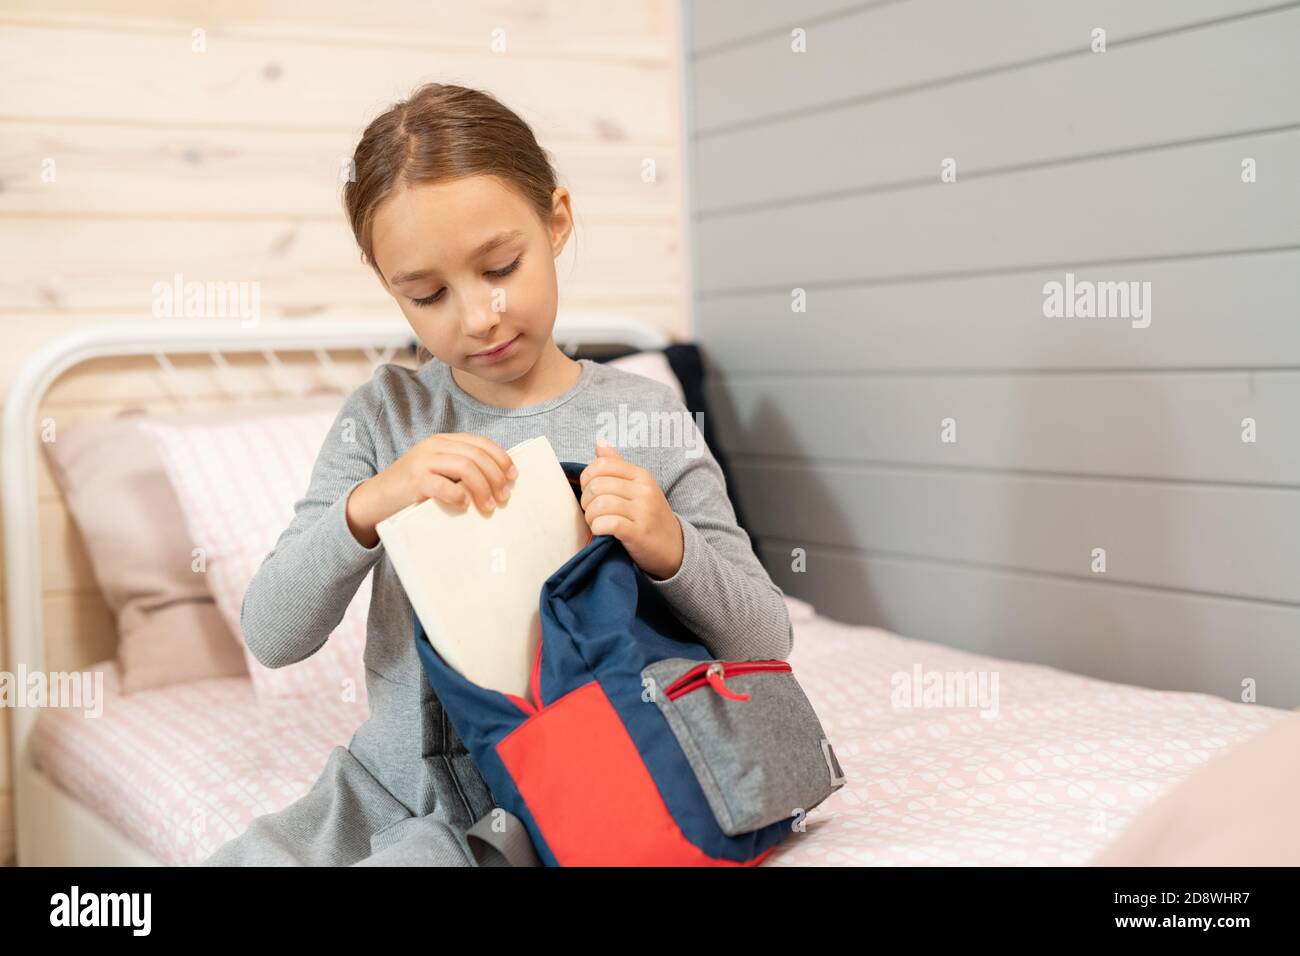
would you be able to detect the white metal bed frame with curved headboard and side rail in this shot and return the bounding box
[0,313,670,866]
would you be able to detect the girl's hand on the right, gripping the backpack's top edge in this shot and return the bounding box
[579,438,685,580]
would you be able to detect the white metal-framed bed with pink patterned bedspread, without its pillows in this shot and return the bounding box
[4,319,1290,866]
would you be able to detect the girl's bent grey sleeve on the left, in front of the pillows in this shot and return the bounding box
[239,378,384,667]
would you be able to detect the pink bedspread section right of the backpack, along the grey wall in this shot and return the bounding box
[767,598,1290,866]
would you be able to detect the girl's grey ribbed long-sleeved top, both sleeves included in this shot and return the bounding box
[239,359,793,827]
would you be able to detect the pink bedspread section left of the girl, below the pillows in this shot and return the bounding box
[33,661,367,865]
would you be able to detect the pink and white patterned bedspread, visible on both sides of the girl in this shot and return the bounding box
[34,597,1288,866]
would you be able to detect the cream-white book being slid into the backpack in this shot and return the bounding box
[377,436,592,704]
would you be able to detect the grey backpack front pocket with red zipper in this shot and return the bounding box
[641,657,845,836]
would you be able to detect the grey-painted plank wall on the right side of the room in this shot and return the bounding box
[688,0,1300,708]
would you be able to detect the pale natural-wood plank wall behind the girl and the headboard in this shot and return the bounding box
[0,0,689,862]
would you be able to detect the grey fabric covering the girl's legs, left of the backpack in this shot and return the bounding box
[200,747,483,866]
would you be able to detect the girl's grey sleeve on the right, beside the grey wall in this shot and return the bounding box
[650,405,794,661]
